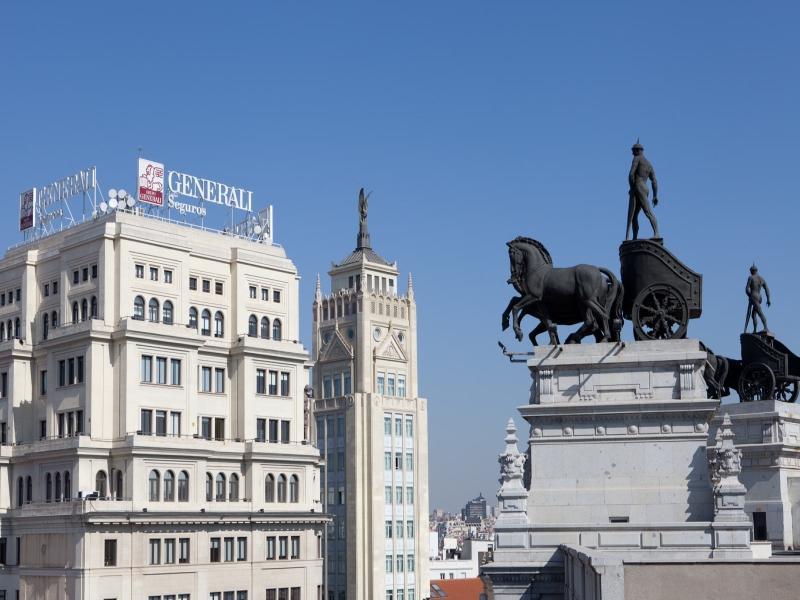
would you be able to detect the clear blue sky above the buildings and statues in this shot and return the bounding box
[0,0,800,509]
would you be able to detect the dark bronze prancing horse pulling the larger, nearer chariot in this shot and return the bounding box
[503,236,623,346]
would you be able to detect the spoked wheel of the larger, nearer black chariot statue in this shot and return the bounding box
[631,283,689,340]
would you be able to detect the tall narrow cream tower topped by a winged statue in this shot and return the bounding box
[312,189,429,600]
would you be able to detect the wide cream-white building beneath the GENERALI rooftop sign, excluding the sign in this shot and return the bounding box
[0,211,326,600]
